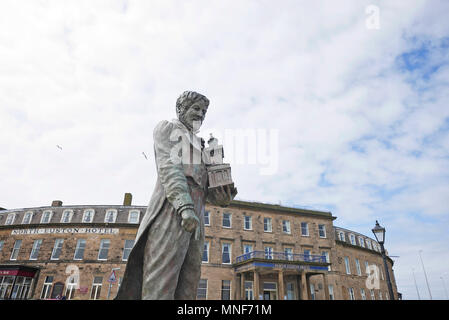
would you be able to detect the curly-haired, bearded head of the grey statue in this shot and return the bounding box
[176,91,209,130]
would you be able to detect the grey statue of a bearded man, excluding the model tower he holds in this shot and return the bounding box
[116,91,237,300]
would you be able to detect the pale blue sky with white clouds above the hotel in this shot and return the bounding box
[0,0,449,299]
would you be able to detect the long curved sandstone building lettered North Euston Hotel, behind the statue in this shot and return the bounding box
[0,194,400,300]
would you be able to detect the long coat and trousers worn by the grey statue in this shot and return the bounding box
[116,119,214,300]
